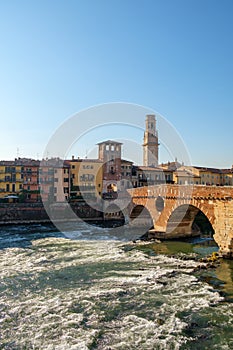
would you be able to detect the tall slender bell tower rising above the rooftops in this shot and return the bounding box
[143,114,159,167]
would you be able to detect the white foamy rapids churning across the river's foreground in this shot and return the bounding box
[0,237,230,350]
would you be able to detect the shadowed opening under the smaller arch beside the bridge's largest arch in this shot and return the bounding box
[129,205,154,230]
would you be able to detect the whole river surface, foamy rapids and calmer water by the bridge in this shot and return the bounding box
[0,222,233,350]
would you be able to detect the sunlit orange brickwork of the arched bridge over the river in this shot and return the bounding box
[128,185,233,258]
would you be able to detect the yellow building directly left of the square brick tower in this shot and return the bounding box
[68,157,103,199]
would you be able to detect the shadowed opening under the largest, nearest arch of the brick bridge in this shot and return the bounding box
[166,204,214,238]
